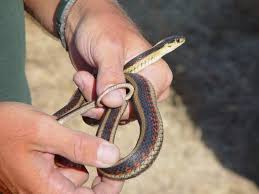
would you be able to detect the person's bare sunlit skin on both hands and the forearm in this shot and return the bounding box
[0,0,175,194]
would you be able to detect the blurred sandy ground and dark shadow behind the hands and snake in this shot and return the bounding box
[26,0,259,194]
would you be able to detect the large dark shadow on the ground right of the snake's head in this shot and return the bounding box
[121,0,259,185]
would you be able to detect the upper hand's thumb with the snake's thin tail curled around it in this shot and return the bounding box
[96,38,126,108]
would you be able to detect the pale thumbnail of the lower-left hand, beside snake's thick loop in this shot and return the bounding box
[97,142,119,168]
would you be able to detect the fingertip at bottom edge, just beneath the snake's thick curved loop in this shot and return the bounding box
[92,177,124,194]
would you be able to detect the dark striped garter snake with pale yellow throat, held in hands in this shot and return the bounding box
[54,36,185,180]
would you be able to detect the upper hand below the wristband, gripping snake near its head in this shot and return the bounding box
[66,0,172,119]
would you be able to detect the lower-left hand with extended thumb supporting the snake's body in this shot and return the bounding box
[0,102,122,194]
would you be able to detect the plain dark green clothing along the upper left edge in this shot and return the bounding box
[0,0,31,103]
